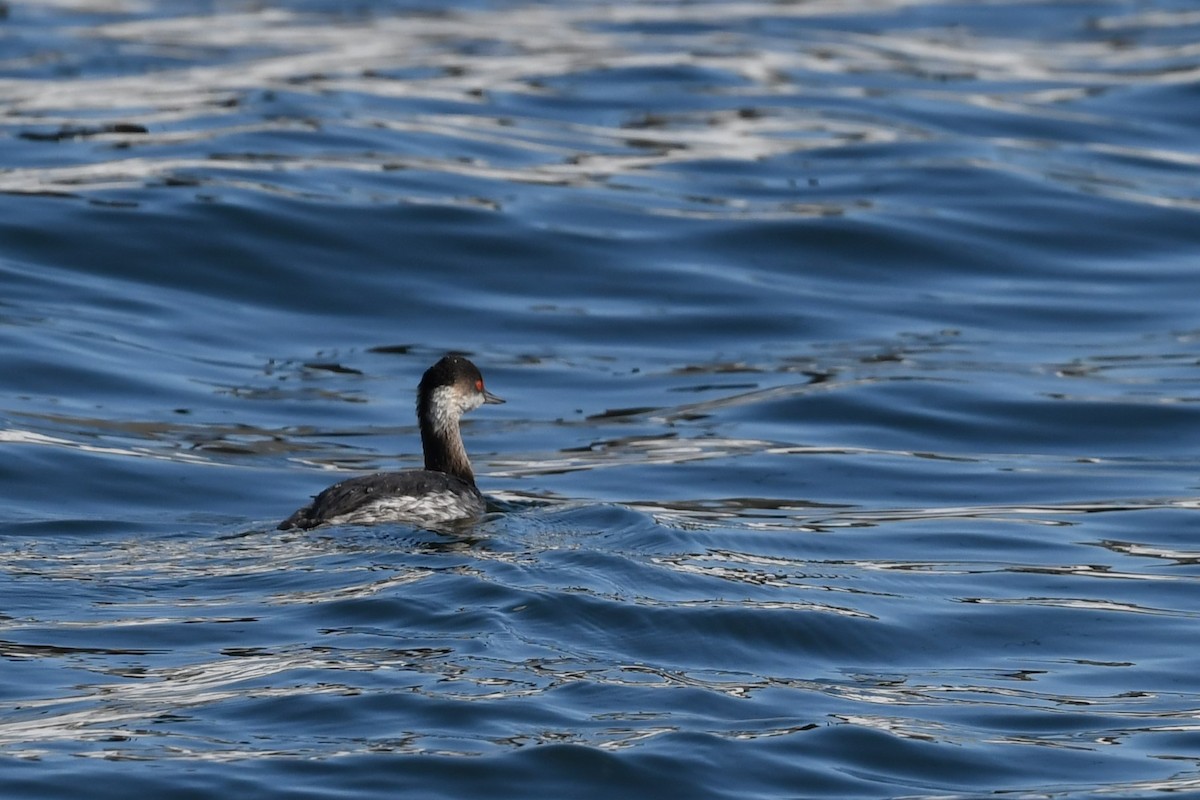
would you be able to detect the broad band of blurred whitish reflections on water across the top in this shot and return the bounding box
[0,1,1200,219]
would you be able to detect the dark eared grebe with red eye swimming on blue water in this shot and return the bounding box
[280,355,504,530]
